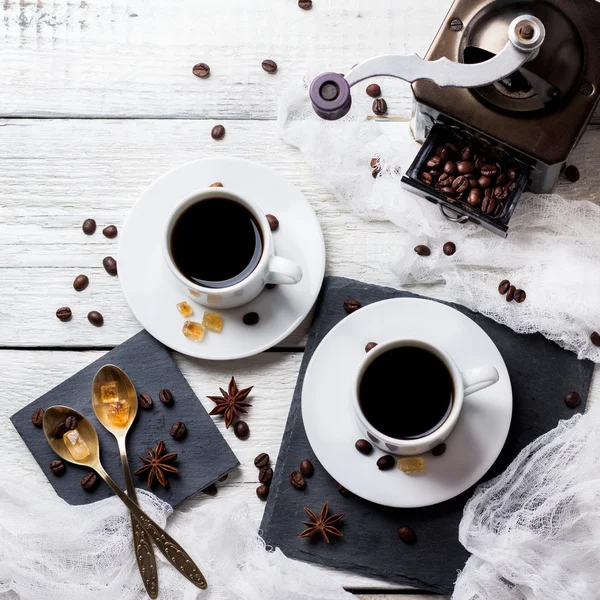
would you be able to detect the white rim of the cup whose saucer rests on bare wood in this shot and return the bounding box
[162,187,273,294]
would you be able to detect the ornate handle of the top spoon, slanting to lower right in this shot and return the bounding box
[95,464,207,590]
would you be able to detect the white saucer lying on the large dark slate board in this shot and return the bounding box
[302,298,512,508]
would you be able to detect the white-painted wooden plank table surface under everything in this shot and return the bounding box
[0,0,600,600]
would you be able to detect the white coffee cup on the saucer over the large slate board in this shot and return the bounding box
[352,339,499,456]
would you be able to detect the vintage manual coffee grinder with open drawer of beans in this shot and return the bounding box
[310,0,600,236]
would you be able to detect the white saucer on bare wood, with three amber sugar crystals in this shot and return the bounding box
[118,158,325,360]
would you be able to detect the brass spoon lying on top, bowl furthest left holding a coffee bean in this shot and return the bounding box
[44,406,207,590]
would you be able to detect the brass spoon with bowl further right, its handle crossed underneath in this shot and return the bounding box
[92,365,158,598]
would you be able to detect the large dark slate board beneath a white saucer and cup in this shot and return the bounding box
[261,277,594,594]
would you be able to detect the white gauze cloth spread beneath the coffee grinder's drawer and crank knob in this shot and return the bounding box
[278,69,600,362]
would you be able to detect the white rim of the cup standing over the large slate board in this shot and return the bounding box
[352,338,464,451]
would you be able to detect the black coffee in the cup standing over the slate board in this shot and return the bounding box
[358,346,454,439]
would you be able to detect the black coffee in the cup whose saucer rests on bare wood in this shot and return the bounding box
[171,198,263,288]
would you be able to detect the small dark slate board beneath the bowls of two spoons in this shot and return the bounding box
[11,331,240,506]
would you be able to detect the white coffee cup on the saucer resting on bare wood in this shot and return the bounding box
[162,187,302,309]
